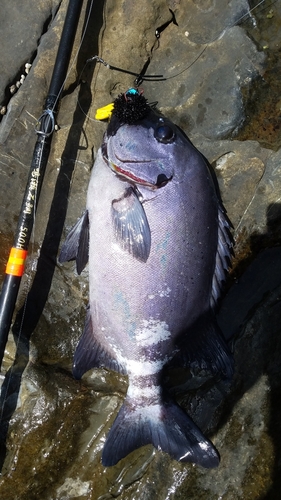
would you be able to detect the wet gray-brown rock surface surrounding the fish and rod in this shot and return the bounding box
[0,0,281,500]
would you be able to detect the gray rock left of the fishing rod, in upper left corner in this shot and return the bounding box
[0,2,80,233]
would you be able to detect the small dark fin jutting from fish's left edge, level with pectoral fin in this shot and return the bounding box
[58,210,89,274]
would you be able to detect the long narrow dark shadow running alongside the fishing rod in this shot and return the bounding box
[0,0,103,469]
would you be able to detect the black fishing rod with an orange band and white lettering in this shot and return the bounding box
[0,0,83,367]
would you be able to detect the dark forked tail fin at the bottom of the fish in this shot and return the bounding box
[102,398,219,468]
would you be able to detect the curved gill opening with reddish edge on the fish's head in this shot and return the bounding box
[102,144,173,189]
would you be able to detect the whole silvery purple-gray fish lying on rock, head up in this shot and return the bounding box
[59,89,233,468]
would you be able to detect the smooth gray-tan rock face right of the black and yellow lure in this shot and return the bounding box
[144,1,265,139]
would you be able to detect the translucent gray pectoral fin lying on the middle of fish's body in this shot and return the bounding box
[112,187,151,262]
